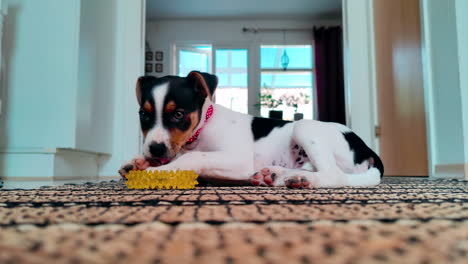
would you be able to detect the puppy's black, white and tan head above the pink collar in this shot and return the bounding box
[136,71,218,165]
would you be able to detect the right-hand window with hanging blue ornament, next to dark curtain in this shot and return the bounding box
[260,45,314,120]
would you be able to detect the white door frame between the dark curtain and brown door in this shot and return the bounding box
[342,0,380,153]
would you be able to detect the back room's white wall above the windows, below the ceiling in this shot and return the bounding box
[146,19,341,76]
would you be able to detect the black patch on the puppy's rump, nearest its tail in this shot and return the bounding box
[343,132,384,177]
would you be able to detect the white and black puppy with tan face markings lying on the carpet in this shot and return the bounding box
[119,71,384,188]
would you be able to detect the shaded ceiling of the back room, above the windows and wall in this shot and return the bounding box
[146,0,341,20]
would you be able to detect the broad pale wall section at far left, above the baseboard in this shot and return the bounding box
[0,0,80,148]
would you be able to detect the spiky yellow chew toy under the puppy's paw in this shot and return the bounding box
[126,170,198,189]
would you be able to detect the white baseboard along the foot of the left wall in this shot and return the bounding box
[0,148,105,181]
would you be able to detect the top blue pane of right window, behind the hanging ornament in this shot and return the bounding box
[260,45,313,69]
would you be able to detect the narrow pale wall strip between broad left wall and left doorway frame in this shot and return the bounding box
[75,0,117,153]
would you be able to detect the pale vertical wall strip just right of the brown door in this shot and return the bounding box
[421,0,465,175]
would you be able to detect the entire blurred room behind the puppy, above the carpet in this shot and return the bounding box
[0,0,468,187]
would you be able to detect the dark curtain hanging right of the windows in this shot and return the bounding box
[314,27,346,124]
